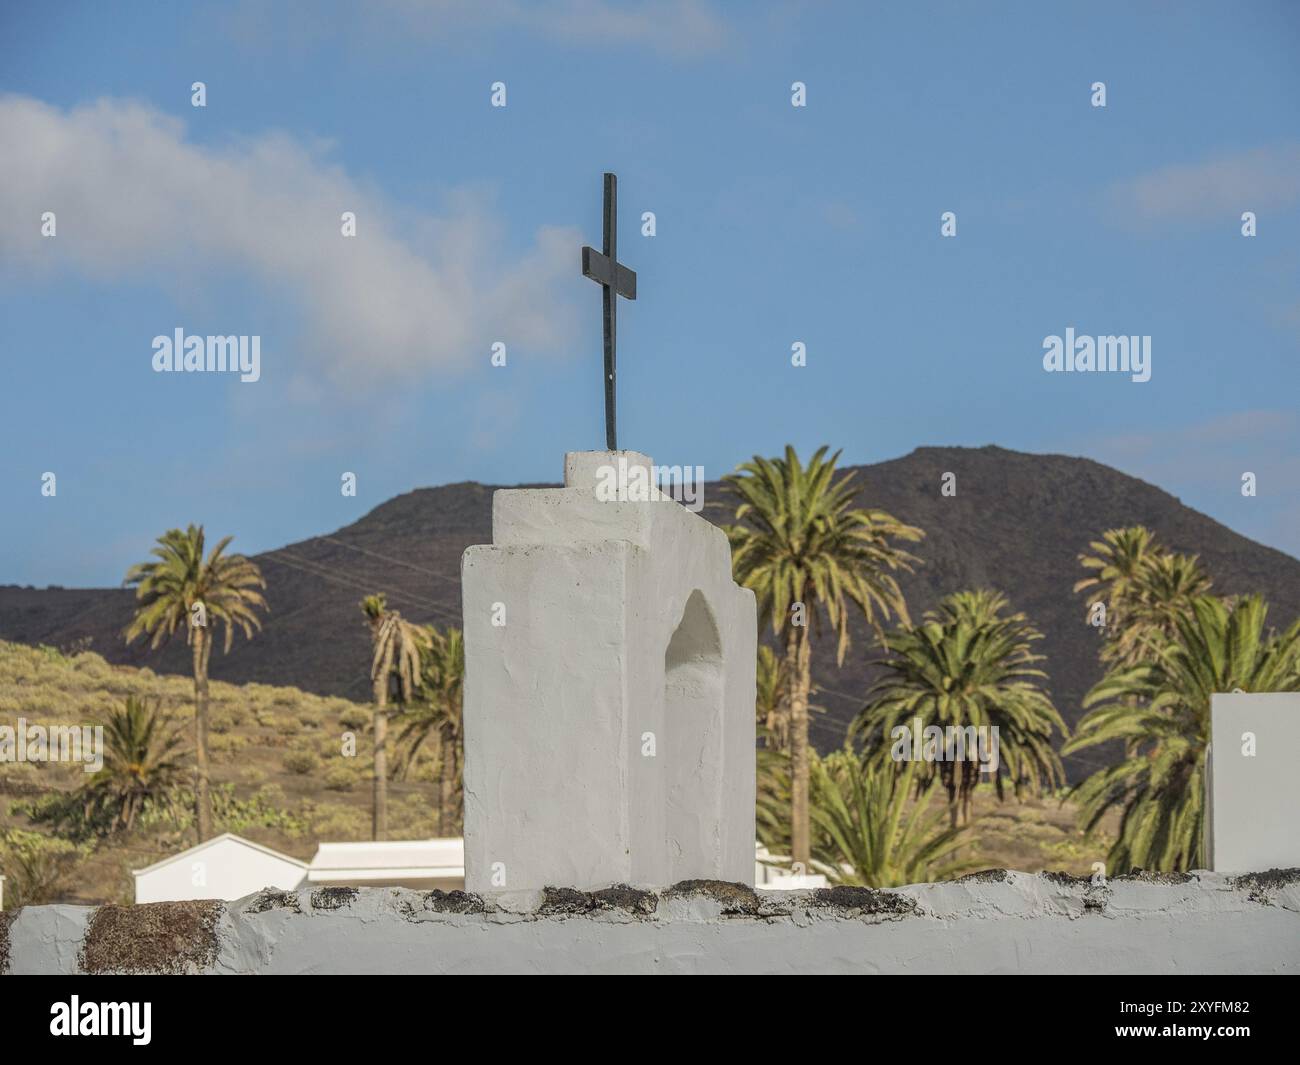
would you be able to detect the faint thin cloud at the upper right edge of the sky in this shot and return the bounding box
[1112,143,1300,222]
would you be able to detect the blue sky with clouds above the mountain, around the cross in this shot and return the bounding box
[0,0,1300,586]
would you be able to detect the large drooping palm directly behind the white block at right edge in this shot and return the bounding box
[1063,596,1300,873]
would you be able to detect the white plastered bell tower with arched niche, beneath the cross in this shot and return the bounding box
[462,451,757,892]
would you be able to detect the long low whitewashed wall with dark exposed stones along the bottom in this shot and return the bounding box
[0,869,1300,974]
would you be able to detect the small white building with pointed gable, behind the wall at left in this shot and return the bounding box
[131,832,307,902]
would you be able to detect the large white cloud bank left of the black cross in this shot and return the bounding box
[0,96,581,388]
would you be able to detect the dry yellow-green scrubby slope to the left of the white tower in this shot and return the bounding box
[0,641,437,902]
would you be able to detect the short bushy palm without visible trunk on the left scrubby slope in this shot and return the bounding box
[79,696,183,834]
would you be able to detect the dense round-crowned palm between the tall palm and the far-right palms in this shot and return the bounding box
[849,589,1067,826]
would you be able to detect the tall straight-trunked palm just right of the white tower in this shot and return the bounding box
[725,446,924,865]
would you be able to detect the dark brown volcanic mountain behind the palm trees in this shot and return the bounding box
[0,447,1300,778]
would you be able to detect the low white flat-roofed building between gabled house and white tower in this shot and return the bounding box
[307,839,465,891]
